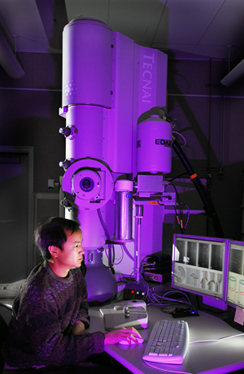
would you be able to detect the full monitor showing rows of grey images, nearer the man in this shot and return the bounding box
[171,234,228,310]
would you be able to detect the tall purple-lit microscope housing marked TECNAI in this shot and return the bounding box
[60,17,171,300]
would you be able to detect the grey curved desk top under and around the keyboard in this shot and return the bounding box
[90,306,244,374]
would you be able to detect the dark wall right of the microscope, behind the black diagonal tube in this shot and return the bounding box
[168,59,244,240]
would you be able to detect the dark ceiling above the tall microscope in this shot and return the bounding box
[0,0,244,66]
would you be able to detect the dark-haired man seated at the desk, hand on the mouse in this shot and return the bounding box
[3,217,140,374]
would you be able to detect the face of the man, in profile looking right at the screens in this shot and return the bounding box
[56,230,84,271]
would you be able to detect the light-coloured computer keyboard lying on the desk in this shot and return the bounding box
[142,320,189,364]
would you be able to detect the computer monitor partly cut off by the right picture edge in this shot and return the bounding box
[226,240,244,308]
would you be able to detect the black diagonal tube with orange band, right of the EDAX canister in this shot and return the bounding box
[172,138,225,238]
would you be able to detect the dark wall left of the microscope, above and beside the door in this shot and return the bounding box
[0,53,65,192]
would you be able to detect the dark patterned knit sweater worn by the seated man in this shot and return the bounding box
[3,262,104,369]
